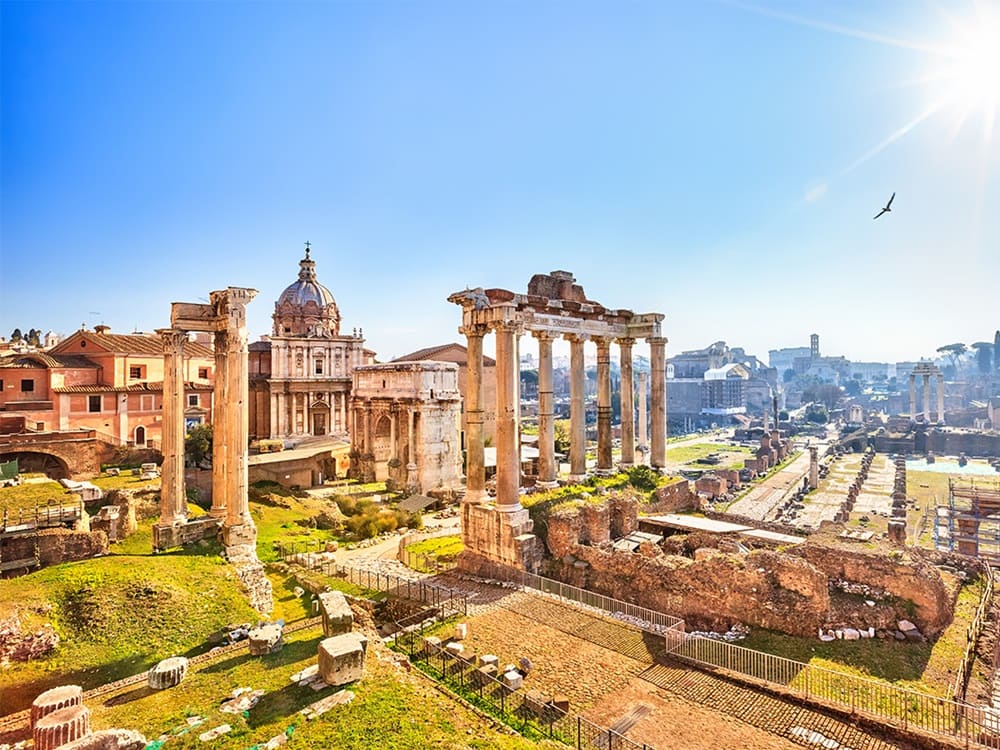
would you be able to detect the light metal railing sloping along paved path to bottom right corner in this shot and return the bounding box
[667,636,1000,747]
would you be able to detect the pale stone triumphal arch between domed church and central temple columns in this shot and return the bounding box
[351,362,462,492]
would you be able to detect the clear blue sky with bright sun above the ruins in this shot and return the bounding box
[0,0,1000,361]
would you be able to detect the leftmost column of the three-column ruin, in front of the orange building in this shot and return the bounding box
[156,328,187,526]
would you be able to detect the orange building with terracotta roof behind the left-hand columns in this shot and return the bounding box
[0,326,215,448]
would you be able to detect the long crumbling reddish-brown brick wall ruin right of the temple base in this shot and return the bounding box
[542,494,957,637]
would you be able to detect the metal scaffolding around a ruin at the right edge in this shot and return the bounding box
[934,478,1000,565]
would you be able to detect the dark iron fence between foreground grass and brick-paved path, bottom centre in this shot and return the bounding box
[393,627,655,750]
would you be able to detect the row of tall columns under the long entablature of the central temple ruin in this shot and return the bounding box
[461,322,666,509]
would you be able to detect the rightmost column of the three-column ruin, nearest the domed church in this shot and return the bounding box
[210,287,257,547]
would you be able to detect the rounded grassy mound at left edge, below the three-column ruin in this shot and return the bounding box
[0,537,259,712]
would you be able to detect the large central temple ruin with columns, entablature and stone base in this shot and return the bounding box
[448,271,667,570]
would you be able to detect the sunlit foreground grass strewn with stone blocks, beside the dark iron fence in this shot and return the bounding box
[83,629,556,750]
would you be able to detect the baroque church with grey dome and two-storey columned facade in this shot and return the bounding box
[249,248,375,443]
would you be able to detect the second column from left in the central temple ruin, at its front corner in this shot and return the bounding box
[494,321,521,510]
